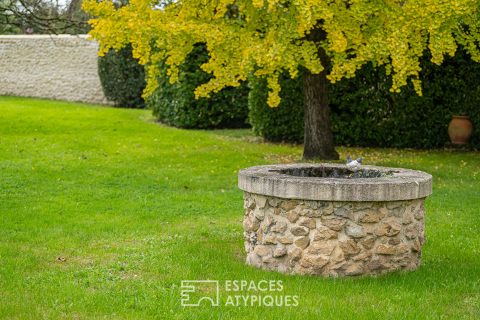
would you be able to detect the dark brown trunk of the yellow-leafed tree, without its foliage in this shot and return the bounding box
[303,29,339,160]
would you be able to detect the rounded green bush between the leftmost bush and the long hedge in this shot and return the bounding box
[147,45,248,129]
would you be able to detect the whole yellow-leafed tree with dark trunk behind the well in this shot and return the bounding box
[83,0,480,159]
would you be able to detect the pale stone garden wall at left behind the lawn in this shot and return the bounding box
[0,35,108,103]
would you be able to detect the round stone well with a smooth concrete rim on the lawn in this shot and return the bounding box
[238,164,432,277]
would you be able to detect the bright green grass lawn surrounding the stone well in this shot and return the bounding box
[0,97,480,319]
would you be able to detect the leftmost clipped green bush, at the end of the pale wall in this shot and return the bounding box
[98,45,145,108]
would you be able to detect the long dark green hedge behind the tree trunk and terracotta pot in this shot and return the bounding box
[249,52,480,149]
